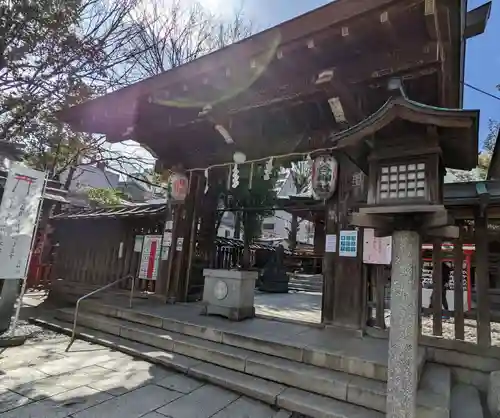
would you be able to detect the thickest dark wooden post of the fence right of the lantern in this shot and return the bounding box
[474,212,491,347]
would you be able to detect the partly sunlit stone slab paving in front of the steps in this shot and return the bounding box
[0,331,290,418]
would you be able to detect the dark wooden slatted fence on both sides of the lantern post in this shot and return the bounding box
[364,233,500,349]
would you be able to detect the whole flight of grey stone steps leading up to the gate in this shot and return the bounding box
[30,301,451,418]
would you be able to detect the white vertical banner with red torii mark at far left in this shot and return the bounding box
[0,163,46,280]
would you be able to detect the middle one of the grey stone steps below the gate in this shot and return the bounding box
[56,309,386,412]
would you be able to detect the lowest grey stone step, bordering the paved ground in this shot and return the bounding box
[32,318,384,418]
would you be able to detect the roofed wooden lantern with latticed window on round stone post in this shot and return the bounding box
[334,94,479,417]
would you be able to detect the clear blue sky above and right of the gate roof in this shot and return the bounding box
[214,0,500,149]
